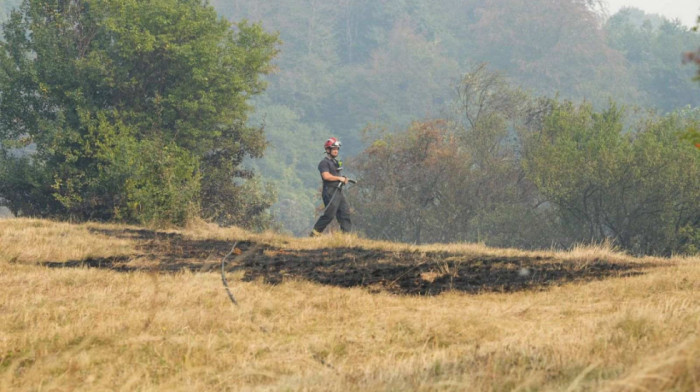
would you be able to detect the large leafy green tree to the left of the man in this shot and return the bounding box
[0,0,277,224]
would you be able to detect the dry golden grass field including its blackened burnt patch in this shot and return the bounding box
[0,219,700,391]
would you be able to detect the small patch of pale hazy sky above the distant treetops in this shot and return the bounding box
[607,0,700,27]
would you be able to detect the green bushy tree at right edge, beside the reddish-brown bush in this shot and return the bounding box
[524,102,700,254]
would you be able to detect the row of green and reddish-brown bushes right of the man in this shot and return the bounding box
[352,68,700,255]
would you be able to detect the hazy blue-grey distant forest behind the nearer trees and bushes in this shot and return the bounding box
[200,0,700,234]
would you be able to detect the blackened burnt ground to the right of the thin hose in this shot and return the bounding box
[233,246,649,295]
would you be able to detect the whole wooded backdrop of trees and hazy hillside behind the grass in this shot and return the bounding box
[0,0,700,254]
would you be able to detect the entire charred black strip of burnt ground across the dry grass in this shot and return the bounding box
[42,229,656,295]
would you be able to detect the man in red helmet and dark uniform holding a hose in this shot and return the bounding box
[311,137,352,237]
